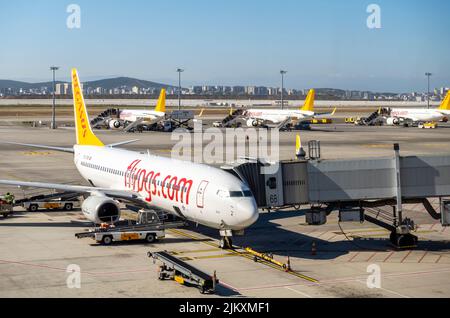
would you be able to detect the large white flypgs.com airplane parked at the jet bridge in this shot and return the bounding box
[0,69,259,248]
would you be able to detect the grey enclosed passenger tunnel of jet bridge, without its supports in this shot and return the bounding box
[227,156,450,208]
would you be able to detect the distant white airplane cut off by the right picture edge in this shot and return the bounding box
[381,91,450,125]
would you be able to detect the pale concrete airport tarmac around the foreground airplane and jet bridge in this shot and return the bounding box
[0,124,450,298]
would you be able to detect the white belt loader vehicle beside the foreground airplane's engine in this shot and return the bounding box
[75,210,186,245]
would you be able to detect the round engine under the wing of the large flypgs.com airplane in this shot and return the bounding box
[81,195,120,224]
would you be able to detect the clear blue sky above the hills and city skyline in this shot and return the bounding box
[0,0,450,92]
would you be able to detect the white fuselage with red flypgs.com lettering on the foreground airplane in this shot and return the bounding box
[74,146,259,231]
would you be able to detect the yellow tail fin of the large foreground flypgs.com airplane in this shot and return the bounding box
[72,69,104,147]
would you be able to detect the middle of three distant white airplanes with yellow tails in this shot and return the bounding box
[243,89,336,127]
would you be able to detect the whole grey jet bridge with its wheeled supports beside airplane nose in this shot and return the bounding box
[224,143,450,246]
